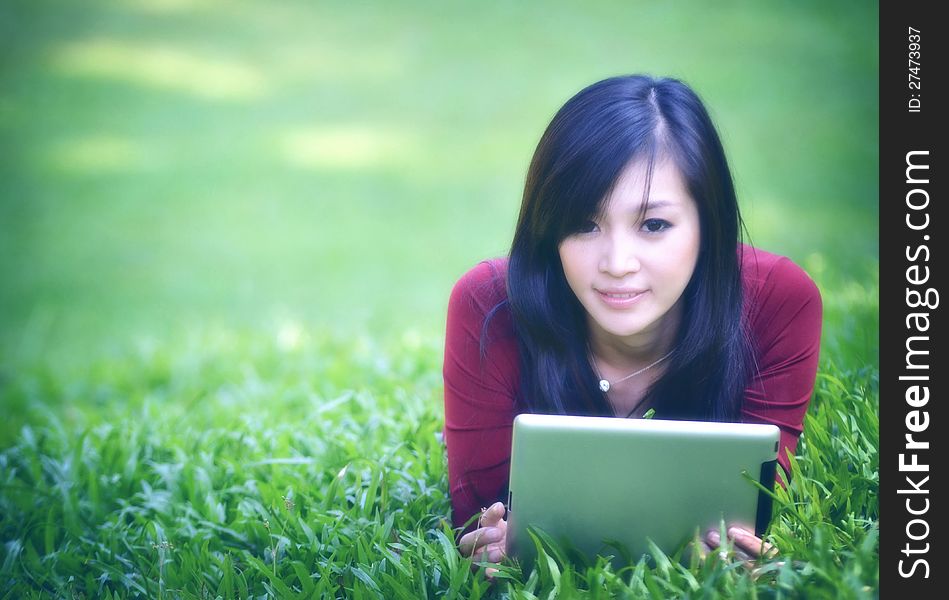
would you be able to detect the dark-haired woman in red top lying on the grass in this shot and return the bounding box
[444,76,821,562]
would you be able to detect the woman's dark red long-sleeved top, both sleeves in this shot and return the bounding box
[443,246,822,527]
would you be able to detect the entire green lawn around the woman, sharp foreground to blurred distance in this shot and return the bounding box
[0,0,879,598]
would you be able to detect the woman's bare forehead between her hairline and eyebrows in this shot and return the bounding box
[603,159,694,210]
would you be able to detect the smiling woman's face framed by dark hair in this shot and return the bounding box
[560,160,701,345]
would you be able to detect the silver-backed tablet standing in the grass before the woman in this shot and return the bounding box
[507,414,780,567]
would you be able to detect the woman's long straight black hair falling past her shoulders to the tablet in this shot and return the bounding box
[507,75,750,421]
